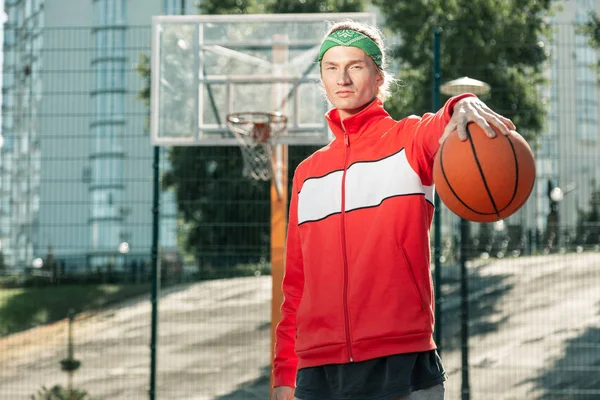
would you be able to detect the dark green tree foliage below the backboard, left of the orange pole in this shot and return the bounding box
[163,147,270,268]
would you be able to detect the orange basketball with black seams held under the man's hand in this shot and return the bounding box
[433,122,535,222]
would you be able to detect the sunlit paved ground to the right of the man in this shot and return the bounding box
[443,254,600,400]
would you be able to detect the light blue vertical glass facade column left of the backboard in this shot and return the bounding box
[90,0,127,266]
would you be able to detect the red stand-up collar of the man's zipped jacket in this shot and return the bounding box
[325,98,390,138]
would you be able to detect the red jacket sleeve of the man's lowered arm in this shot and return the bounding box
[273,175,304,387]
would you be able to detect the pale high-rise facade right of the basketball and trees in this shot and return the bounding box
[536,0,600,231]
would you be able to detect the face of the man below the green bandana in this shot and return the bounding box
[321,46,383,119]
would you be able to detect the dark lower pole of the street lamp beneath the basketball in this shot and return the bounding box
[460,218,471,400]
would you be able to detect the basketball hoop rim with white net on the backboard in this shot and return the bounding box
[227,112,287,181]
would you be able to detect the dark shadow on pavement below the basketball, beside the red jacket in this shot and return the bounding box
[442,266,514,351]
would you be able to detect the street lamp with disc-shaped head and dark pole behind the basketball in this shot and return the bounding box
[440,76,490,400]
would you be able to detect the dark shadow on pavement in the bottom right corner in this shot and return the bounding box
[527,305,600,400]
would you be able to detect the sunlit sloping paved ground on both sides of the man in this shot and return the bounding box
[0,253,600,400]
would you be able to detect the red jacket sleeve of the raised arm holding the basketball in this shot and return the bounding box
[401,93,475,185]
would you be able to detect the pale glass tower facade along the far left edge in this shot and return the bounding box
[0,0,44,267]
